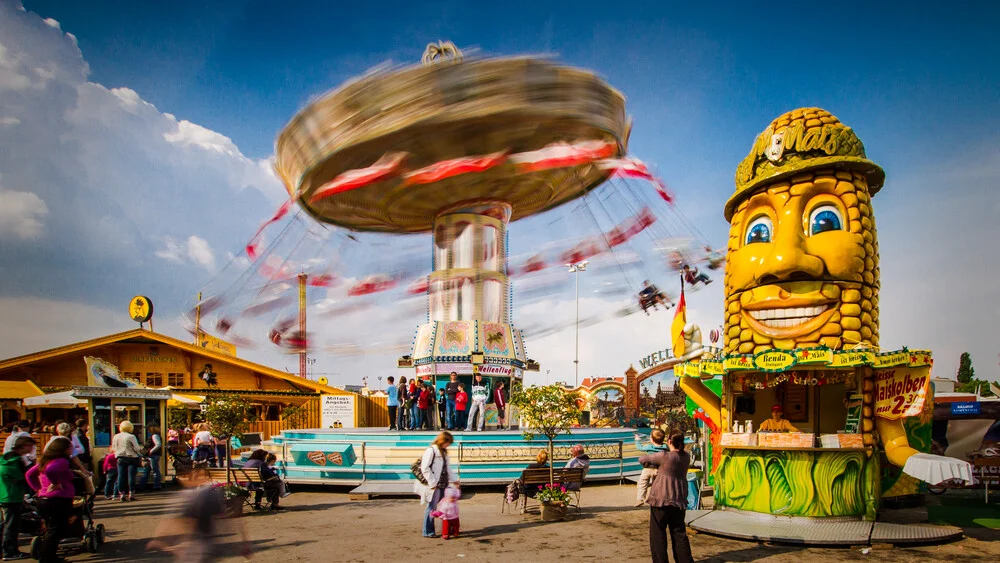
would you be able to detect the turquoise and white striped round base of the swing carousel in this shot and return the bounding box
[265,428,648,486]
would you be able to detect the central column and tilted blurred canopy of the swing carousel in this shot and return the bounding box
[276,43,630,384]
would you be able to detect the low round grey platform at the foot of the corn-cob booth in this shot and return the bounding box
[687,510,962,546]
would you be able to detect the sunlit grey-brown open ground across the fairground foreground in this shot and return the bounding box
[43,485,1000,563]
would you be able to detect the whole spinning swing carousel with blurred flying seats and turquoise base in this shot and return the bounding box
[182,43,718,492]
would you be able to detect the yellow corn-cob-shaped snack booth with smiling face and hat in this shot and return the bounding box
[674,108,971,543]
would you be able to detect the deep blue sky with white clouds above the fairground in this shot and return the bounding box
[0,2,1000,384]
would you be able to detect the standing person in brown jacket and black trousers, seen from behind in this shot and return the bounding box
[639,434,694,563]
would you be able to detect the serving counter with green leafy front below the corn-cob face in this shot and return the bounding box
[675,347,931,519]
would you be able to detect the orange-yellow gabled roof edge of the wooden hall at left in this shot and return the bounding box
[0,328,354,398]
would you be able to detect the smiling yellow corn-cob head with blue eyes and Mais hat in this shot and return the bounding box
[725,108,885,354]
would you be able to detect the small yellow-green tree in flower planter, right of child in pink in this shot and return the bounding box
[510,385,582,482]
